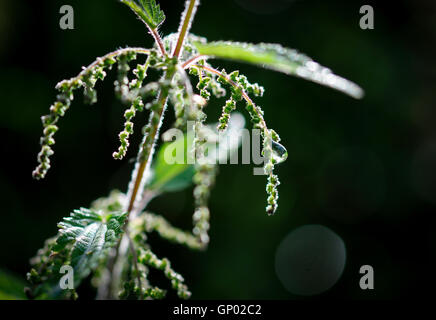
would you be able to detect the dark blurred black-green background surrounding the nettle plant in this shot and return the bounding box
[0,0,436,299]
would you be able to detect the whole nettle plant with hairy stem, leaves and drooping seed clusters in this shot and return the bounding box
[26,0,363,299]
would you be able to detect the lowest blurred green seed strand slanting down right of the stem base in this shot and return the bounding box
[138,249,191,299]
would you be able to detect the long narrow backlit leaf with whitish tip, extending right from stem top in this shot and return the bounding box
[194,41,364,99]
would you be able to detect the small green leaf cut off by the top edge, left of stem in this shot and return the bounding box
[120,0,165,29]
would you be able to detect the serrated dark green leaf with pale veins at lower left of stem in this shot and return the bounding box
[53,208,127,286]
